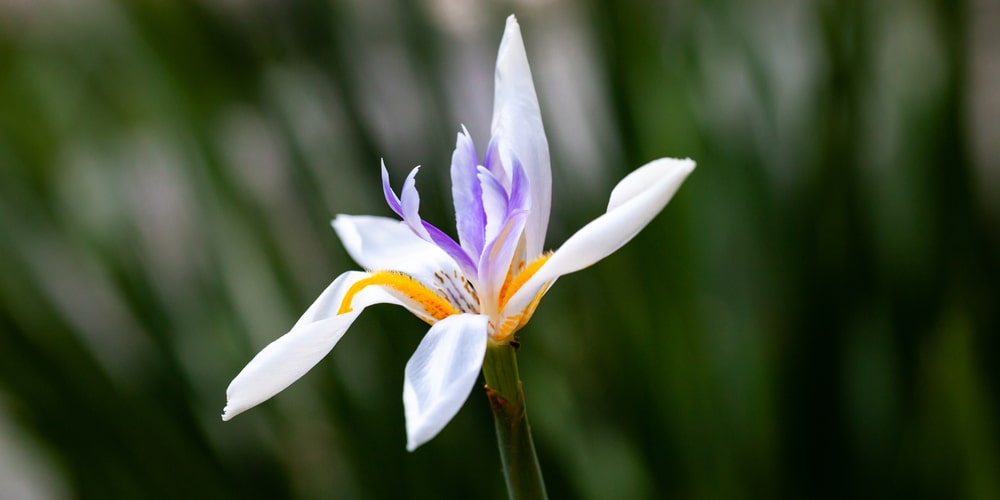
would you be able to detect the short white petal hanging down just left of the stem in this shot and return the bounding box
[403,314,489,451]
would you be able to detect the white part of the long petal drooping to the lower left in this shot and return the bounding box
[222,271,399,420]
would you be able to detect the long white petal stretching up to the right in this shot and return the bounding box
[505,158,695,314]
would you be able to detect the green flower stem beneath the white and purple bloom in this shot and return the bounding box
[483,343,548,500]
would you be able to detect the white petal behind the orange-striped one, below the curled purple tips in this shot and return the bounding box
[333,214,459,283]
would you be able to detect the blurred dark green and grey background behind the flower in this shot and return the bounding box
[0,0,1000,499]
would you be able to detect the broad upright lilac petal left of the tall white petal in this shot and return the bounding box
[451,129,486,259]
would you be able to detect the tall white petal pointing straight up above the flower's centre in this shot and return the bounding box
[492,16,552,259]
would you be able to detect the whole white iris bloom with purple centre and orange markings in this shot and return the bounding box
[222,16,694,451]
